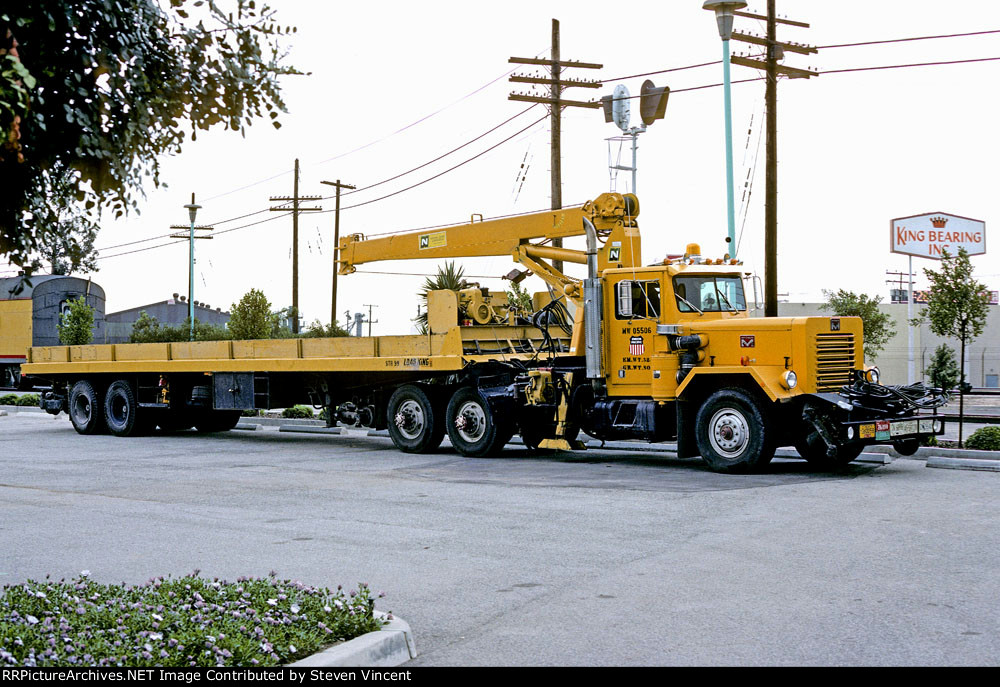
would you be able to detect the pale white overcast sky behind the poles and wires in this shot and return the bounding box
[3,0,1000,334]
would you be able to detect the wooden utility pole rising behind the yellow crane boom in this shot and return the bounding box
[507,19,604,272]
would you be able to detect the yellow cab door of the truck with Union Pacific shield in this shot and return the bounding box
[604,273,663,396]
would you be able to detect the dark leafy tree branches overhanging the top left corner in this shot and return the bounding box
[0,0,298,269]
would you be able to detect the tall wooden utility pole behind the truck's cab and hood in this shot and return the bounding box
[730,0,819,317]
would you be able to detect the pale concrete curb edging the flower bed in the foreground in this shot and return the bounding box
[289,611,417,668]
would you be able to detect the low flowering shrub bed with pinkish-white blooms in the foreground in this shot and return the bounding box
[0,571,382,667]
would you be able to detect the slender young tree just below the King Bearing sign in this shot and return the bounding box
[916,248,989,448]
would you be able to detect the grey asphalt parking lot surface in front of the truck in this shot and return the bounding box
[0,412,1000,665]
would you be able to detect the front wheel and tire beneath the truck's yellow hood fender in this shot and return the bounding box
[695,389,775,472]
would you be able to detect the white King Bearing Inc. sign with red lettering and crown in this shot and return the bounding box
[889,212,986,260]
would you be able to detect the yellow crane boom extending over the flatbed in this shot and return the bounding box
[337,193,639,274]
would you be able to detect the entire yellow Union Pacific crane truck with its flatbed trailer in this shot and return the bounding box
[24,193,947,471]
